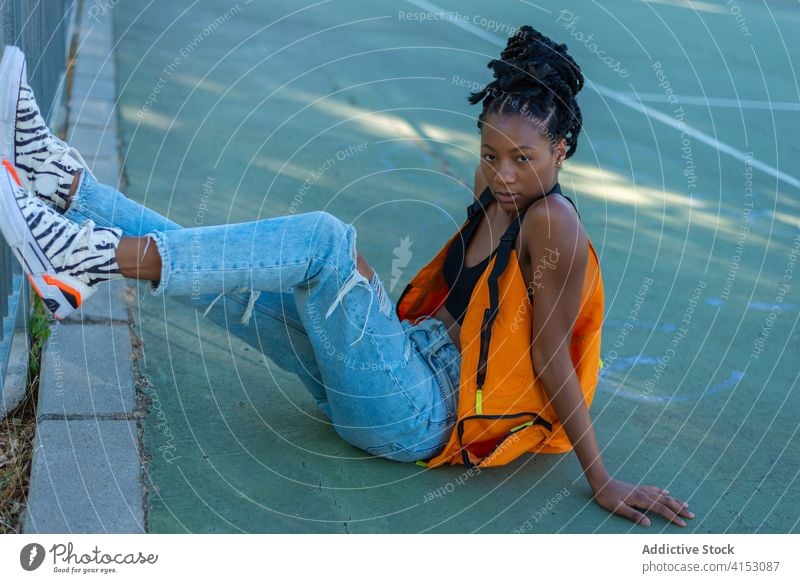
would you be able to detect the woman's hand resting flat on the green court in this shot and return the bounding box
[594,479,694,526]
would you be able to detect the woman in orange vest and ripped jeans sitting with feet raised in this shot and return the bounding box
[0,27,693,526]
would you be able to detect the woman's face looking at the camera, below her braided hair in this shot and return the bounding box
[480,114,566,214]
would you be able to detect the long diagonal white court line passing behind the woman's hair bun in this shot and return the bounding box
[406,0,800,190]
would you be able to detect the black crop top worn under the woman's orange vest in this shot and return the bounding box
[443,183,578,325]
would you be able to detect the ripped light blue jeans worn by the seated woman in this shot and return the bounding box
[64,172,461,462]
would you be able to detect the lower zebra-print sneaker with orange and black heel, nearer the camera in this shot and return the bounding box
[0,160,123,320]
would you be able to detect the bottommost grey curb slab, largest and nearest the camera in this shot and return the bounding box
[23,419,144,534]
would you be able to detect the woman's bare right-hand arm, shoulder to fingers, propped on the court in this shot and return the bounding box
[522,200,693,526]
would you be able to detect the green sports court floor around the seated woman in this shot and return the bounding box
[104,0,800,533]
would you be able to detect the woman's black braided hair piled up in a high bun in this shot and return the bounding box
[469,26,583,158]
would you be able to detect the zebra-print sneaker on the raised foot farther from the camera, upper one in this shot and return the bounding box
[0,46,87,212]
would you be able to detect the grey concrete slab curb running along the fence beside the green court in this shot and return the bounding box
[23,2,145,533]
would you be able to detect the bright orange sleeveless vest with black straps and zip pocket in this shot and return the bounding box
[396,184,603,467]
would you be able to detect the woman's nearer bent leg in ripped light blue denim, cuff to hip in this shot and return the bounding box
[148,212,455,461]
